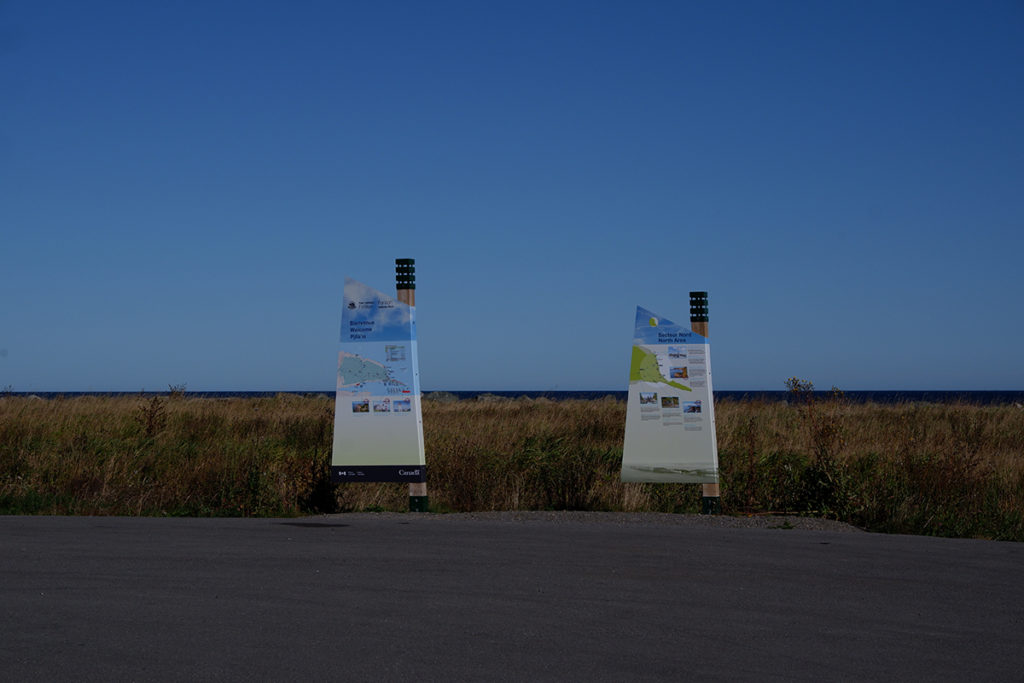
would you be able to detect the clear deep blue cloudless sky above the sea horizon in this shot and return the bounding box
[0,0,1024,391]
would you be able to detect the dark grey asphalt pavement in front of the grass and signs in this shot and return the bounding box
[0,514,1024,681]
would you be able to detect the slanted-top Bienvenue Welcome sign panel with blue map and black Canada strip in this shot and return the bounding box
[331,278,426,481]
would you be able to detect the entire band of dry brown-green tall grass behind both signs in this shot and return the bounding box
[0,393,1024,541]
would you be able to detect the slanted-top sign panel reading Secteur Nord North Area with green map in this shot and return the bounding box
[622,306,718,483]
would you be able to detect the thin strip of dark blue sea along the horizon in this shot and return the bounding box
[8,389,1024,405]
